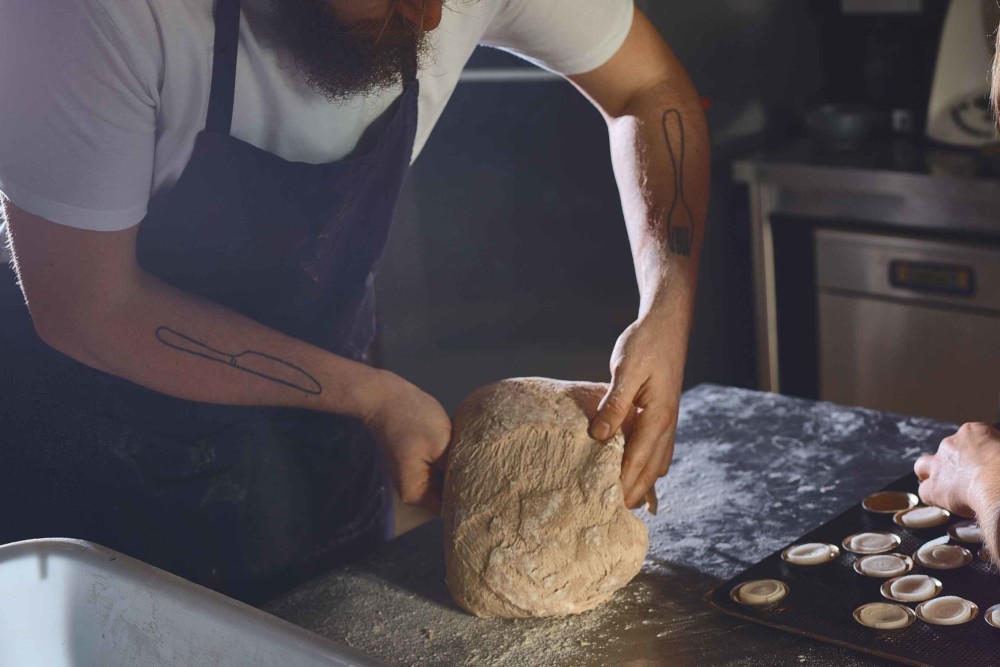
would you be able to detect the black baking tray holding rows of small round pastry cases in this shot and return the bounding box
[706,474,1000,667]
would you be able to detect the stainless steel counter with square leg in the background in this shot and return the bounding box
[733,138,1000,391]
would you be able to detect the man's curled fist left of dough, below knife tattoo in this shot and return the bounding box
[364,373,451,512]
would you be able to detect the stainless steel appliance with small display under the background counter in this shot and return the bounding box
[815,229,1000,422]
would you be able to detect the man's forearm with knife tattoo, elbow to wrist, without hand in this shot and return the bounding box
[37,273,385,417]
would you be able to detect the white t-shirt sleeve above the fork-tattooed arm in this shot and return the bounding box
[482,0,635,75]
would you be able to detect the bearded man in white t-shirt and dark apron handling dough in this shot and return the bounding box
[0,0,708,600]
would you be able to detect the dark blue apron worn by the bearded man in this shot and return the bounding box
[0,0,418,601]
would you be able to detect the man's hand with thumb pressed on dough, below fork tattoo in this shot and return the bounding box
[590,314,687,507]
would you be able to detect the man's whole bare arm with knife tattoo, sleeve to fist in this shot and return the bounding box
[6,198,451,508]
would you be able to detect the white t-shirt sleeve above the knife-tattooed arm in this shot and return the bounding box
[0,0,156,231]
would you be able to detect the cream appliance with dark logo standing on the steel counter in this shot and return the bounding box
[927,0,1000,148]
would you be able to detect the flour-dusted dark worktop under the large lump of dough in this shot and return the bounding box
[267,385,954,667]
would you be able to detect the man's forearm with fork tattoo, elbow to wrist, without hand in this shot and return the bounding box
[609,76,709,329]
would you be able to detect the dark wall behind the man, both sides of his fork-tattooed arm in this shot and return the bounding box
[379,0,821,408]
